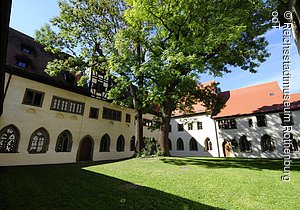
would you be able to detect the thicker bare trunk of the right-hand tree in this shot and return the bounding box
[159,105,172,156]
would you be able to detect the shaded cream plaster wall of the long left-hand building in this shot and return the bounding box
[0,75,134,166]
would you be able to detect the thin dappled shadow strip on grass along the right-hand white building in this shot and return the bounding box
[161,157,300,171]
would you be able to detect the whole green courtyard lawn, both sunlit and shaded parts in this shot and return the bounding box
[0,158,300,210]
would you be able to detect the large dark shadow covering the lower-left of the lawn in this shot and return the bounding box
[0,162,223,210]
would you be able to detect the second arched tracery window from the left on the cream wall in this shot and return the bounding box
[28,128,49,154]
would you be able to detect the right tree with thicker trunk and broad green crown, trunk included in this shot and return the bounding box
[127,0,273,155]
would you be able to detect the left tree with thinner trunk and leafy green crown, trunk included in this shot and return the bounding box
[36,0,146,152]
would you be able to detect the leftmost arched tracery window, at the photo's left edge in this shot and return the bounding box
[0,125,20,153]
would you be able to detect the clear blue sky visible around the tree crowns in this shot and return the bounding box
[10,0,300,93]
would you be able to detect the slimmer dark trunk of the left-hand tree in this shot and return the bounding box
[135,110,143,153]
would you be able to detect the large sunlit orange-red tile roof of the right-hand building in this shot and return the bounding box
[214,82,284,118]
